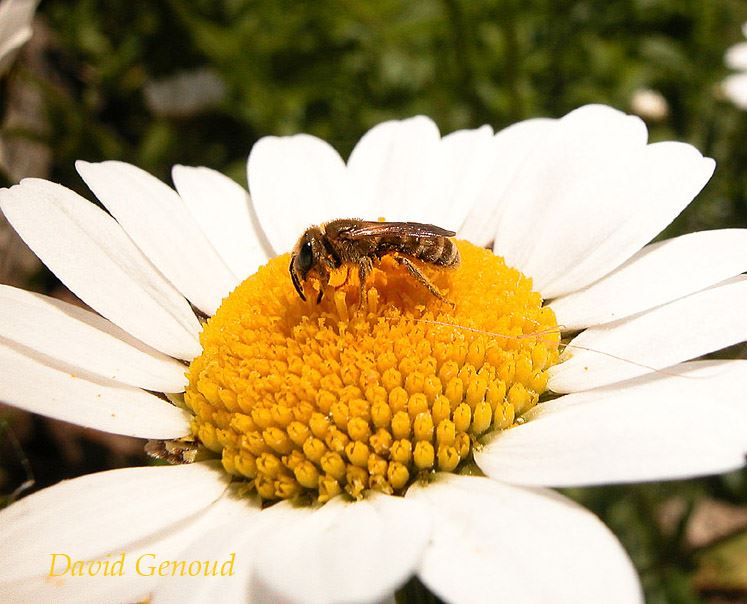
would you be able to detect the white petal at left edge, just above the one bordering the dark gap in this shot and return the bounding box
[0,285,187,392]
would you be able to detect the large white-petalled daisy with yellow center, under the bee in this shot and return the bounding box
[0,105,747,602]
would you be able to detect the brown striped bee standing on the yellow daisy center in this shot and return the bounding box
[288,218,460,306]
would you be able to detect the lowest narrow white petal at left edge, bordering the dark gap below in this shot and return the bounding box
[0,342,191,439]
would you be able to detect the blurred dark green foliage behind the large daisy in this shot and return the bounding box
[0,0,747,602]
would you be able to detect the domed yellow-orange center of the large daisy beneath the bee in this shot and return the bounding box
[185,241,560,502]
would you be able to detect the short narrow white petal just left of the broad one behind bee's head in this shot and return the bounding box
[171,166,272,281]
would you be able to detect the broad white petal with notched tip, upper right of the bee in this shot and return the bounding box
[494,106,714,298]
